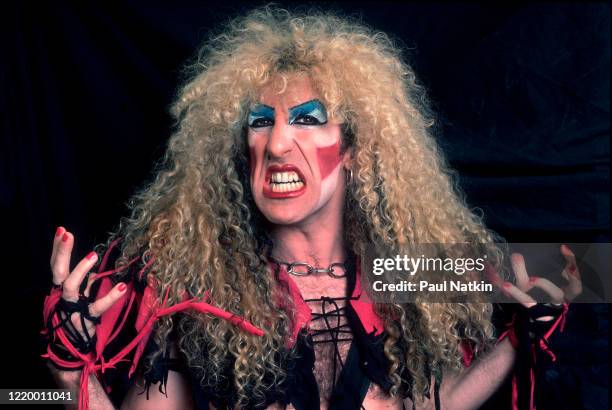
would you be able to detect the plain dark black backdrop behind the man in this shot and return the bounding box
[0,1,610,409]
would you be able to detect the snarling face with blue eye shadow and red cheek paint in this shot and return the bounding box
[247,77,349,225]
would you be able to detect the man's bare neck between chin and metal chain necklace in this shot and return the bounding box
[270,203,346,267]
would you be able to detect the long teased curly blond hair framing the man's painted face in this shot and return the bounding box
[105,7,502,405]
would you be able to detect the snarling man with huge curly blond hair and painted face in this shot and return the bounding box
[45,8,580,409]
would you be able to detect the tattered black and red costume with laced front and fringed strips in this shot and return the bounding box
[42,241,568,410]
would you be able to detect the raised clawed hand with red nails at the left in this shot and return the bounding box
[51,227,126,353]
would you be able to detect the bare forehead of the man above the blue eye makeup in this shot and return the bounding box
[259,75,319,110]
